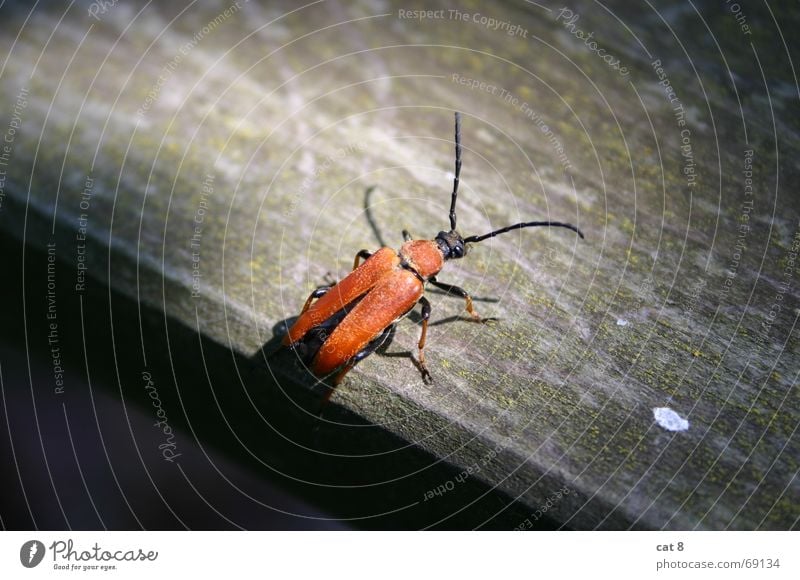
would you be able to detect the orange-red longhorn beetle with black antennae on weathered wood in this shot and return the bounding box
[282,112,584,399]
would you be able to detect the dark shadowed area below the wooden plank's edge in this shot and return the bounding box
[0,230,554,529]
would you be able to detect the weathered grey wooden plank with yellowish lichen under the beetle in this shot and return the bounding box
[0,2,800,529]
